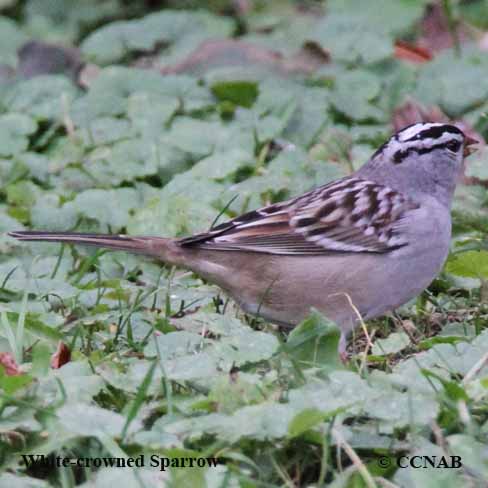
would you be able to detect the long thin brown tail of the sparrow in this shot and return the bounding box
[9,231,180,264]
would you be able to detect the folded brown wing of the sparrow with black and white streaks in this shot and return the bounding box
[179,177,417,255]
